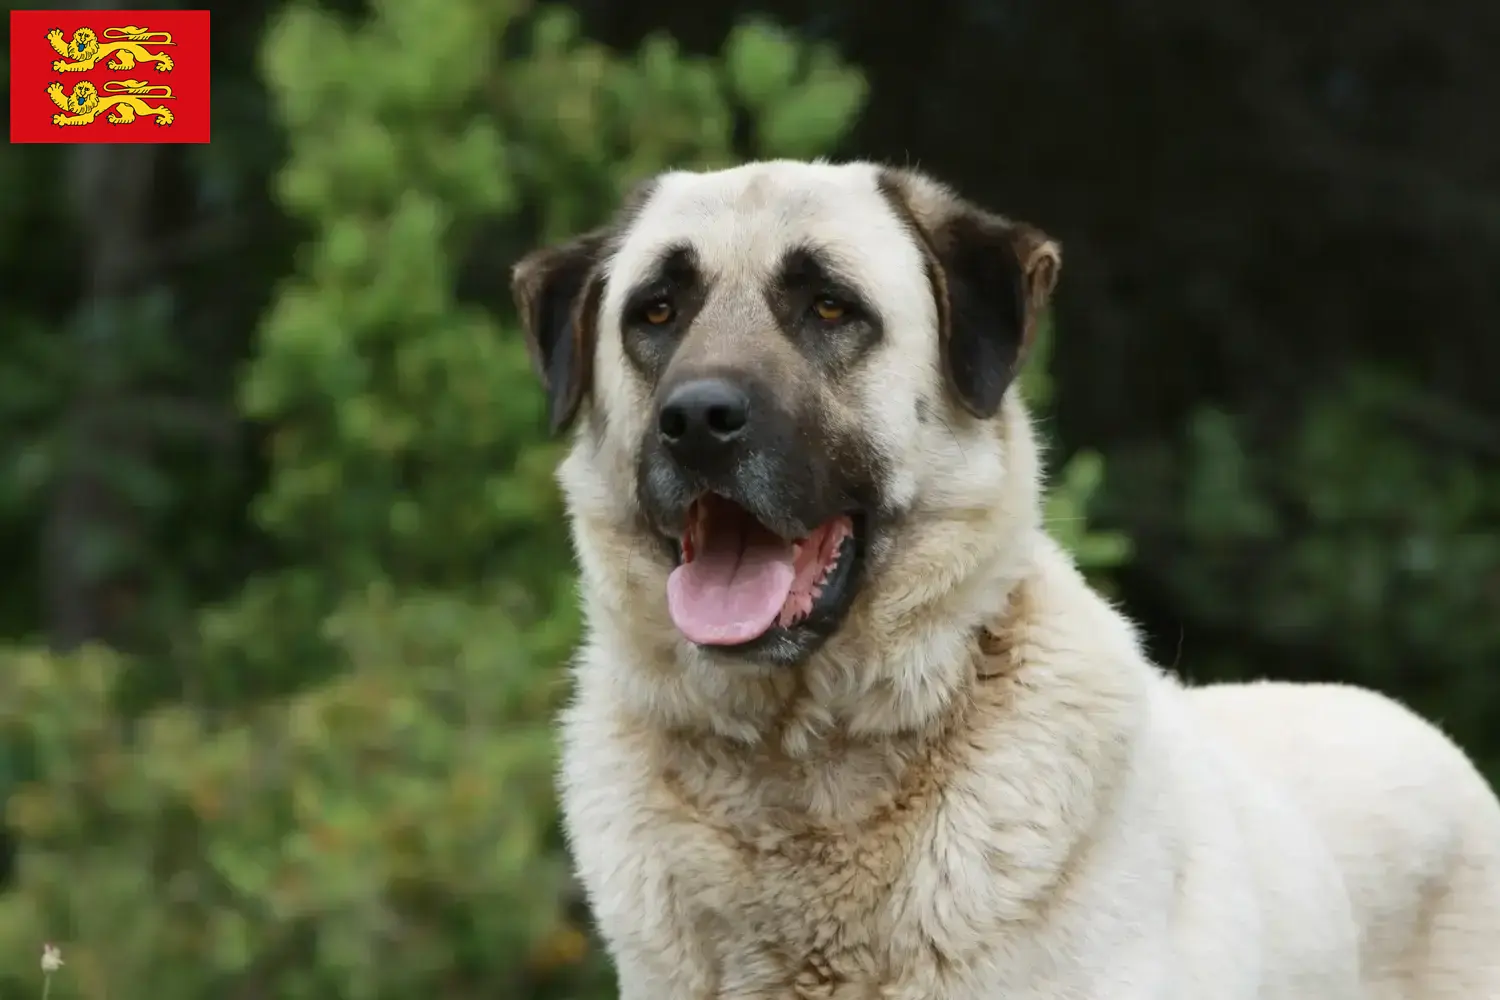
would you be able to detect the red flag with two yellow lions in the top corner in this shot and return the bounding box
[11,10,212,142]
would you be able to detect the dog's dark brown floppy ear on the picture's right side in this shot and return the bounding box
[882,175,1062,417]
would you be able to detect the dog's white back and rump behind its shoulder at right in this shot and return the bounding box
[1188,682,1500,1000]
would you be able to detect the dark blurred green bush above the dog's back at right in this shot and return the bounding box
[1112,372,1500,774]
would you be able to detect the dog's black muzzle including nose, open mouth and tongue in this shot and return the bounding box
[644,372,864,660]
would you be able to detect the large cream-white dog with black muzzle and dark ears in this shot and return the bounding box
[512,160,1500,1000]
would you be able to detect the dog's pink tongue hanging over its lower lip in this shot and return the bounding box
[666,525,797,646]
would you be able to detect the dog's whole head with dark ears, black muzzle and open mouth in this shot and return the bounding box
[515,162,1059,692]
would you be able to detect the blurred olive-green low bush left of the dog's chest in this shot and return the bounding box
[0,602,576,1000]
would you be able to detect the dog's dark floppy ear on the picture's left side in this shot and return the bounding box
[510,229,609,433]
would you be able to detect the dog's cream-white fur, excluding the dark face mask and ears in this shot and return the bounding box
[543,162,1500,1000]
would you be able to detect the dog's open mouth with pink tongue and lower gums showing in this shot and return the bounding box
[666,493,858,646]
